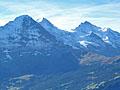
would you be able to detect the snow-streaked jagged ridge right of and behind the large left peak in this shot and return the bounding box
[40,14,120,56]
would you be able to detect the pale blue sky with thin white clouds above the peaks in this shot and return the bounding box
[0,0,120,32]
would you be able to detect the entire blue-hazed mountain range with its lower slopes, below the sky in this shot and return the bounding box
[0,15,120,90]
